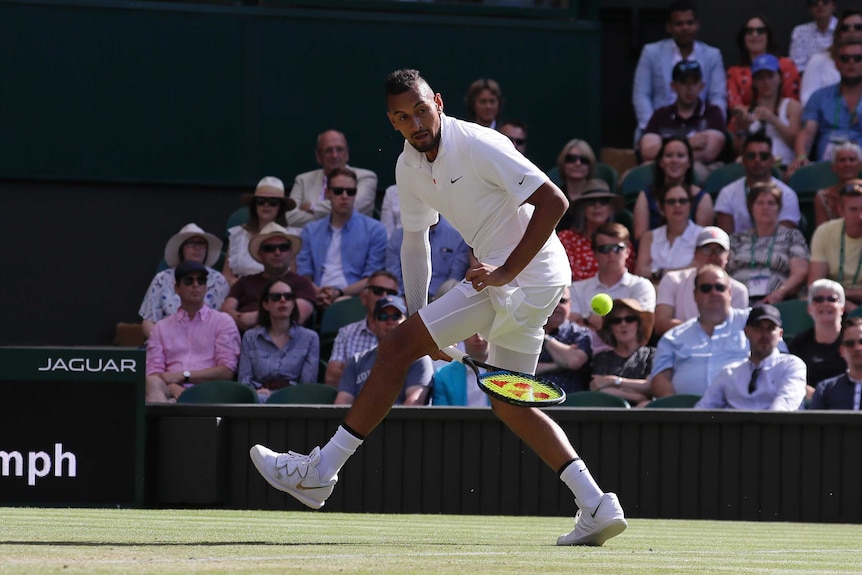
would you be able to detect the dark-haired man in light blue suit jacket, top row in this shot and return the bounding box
[632,0,727,138]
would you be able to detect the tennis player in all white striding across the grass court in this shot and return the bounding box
[250,70,628,545]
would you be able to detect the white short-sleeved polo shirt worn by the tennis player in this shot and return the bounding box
[395,115,572,287]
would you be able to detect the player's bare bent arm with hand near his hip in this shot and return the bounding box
[470,181,569,290]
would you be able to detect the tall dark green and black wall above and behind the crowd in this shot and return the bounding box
[0,1,600,345]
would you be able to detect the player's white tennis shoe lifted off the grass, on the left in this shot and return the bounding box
[248,445,338,509]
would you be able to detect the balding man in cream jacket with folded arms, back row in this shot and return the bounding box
[287,130,377,228]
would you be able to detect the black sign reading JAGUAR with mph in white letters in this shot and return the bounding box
[0,347,144,506]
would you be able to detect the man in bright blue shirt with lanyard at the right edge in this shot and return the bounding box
[789,36,862,169]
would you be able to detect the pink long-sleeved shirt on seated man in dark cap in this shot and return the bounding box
[147,306,240,375]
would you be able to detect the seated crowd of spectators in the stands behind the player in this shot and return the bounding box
[139,0,862,411]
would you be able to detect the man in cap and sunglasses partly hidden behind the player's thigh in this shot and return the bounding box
[335,296,434,405]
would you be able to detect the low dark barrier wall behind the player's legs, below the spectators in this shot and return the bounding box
[147,406,862,523]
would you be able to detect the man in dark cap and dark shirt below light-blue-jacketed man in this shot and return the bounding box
[638,60,725,181]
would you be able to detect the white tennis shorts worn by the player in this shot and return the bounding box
[419,280,565,357]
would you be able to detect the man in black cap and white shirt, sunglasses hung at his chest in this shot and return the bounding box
[695,304,806,411]
